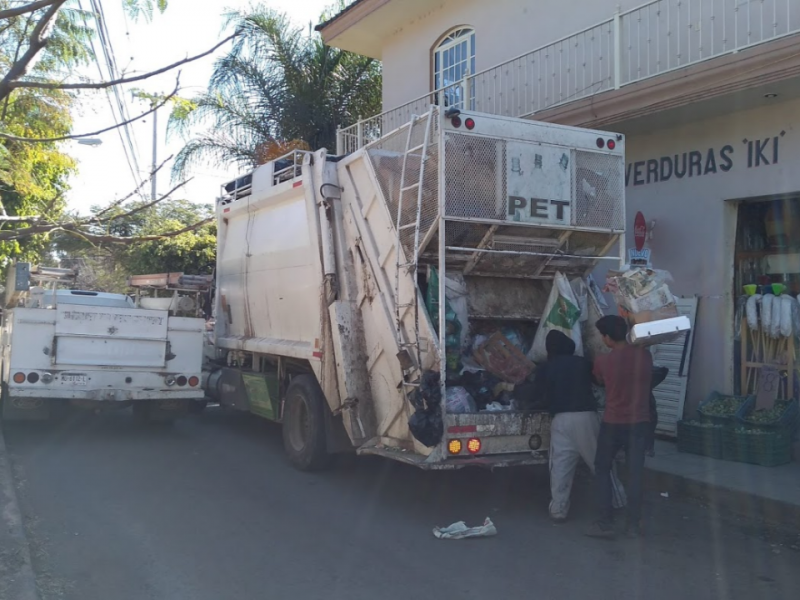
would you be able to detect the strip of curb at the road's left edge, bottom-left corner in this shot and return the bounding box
[0,427,39,600]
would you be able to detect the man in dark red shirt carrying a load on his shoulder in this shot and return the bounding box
[586,316,653,539]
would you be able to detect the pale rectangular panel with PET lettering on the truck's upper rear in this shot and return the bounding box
[506,142,573,225]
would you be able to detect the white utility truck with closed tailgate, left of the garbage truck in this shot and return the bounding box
[2,263,205,421]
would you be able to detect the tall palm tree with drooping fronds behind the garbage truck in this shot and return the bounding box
[170,5,381,177]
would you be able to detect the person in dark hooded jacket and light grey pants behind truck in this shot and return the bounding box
[533,330,626,522]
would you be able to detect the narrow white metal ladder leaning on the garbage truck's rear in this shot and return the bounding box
[394,110,434,392]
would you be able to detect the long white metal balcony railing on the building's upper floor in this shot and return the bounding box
[337,0,800,154]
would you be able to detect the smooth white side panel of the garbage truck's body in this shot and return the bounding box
[217,185,321,359]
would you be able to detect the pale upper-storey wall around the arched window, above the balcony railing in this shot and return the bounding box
[383,0,641,110]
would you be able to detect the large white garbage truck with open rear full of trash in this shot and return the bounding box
[205,106,644,470]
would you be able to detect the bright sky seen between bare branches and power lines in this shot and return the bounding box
[65,0,330,212]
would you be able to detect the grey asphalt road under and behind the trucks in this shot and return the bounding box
[1,410,800,600]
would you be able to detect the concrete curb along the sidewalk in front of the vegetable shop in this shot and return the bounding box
[645,467,800,531]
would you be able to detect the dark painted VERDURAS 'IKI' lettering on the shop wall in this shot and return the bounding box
[625,131,786,187]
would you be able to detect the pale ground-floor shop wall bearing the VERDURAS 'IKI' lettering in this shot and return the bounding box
[626,101,800,410]
